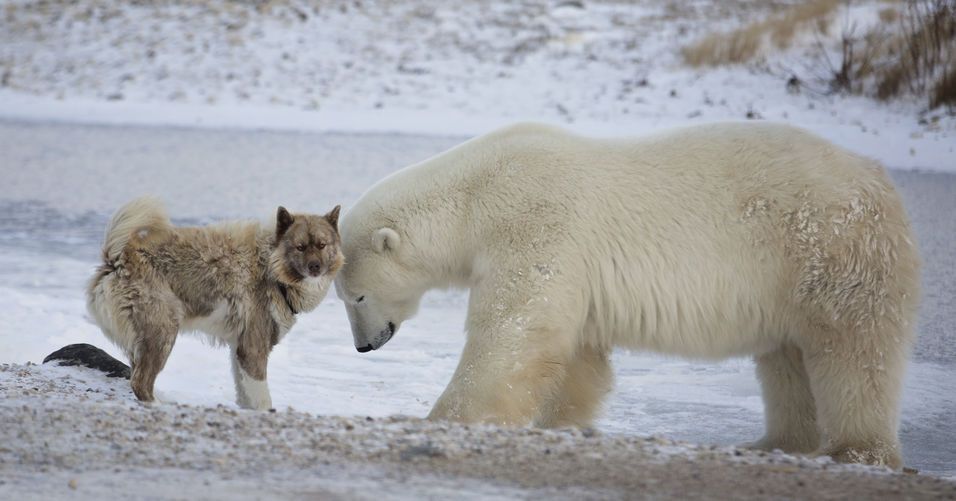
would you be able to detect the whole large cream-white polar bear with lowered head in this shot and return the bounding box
[336,123,919,468]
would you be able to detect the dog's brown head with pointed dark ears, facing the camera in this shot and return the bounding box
[272,206,345,284]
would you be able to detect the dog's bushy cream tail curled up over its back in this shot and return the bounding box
[103,197,173,263]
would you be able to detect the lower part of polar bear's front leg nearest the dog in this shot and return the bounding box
[428,316,573,426]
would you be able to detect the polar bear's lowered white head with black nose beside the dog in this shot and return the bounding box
[335,219,427,353]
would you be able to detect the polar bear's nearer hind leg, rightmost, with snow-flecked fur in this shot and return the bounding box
[797,174,919,468]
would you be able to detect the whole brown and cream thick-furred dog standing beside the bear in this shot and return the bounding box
[87,198,343,409]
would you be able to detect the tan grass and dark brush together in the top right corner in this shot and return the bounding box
[683,0,956,108]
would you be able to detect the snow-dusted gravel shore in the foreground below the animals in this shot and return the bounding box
[0,364,956,500]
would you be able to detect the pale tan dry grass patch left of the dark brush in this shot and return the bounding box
[682,0,841,66]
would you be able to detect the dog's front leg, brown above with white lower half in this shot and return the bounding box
[231,322,272,410]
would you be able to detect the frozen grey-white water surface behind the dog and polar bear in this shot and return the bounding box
[0,118,956,484]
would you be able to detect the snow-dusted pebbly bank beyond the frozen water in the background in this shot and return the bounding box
[0,0,956,171]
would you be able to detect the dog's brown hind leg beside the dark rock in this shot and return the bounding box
[130,290,183,402]
